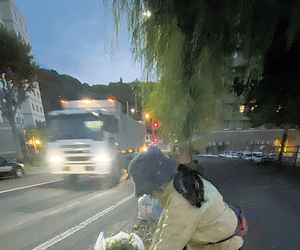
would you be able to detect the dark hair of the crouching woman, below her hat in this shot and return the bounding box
[173,164,204,208]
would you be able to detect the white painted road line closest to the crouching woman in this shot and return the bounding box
[33,194,134,250]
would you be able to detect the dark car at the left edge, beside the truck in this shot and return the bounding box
[0,157,25,178]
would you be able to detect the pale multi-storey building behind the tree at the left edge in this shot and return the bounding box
[0,0,45,157]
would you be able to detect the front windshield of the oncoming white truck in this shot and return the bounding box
[48,114,105,141]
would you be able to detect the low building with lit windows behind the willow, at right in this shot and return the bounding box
[193,54,300,157]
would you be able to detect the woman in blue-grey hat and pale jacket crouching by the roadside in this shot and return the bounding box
[129,147,243,250]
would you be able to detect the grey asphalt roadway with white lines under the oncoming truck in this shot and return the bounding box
[0,174,137,250]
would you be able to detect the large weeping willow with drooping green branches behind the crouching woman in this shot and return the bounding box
[104,0,278,162]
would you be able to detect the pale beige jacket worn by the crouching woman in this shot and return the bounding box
[150,179,243,250]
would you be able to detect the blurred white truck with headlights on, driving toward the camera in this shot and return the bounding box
[47,98,145,184]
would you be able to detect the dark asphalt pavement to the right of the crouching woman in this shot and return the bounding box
[198,157,300,250]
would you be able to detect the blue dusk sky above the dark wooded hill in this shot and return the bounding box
[14,0,141,85]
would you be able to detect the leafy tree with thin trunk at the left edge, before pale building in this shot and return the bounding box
[0,27,36,159]
